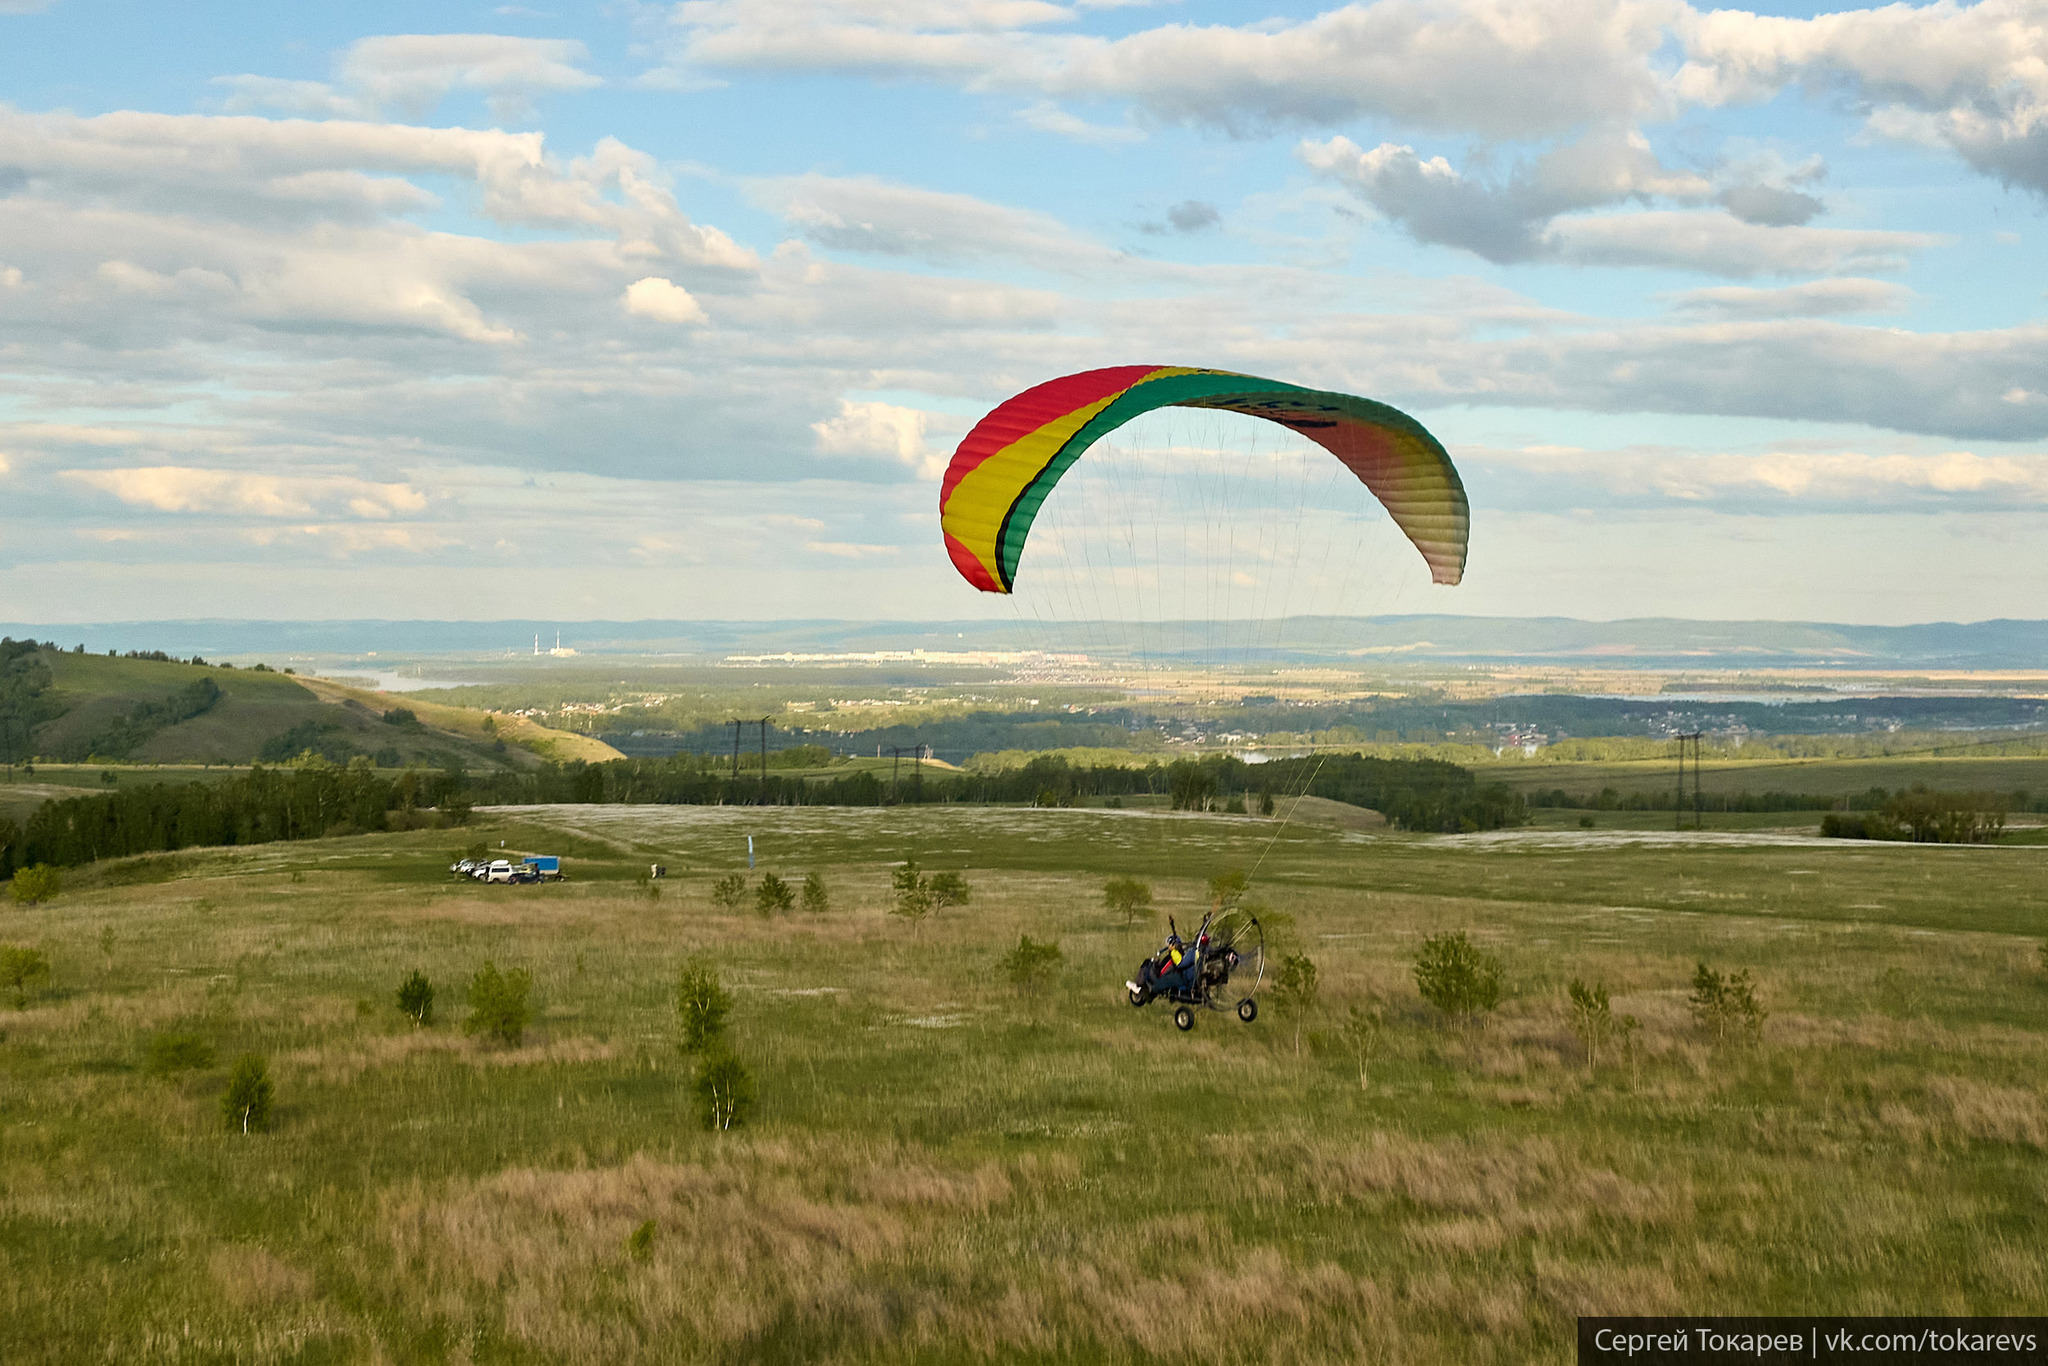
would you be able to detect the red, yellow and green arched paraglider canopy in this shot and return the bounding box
[938,365,1470,594]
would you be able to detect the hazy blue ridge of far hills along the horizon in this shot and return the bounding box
[0,616,2048,670]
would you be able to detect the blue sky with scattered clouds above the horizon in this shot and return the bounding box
[0,0,2048,623]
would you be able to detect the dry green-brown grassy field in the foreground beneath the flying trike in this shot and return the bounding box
[0,807,2048,1364]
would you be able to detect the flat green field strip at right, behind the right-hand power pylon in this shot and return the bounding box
[1473,756,2048,797]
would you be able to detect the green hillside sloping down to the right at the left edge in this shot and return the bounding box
[0,641,616,770]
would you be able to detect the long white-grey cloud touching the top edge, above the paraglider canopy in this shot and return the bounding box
[655,0,1671,139]
